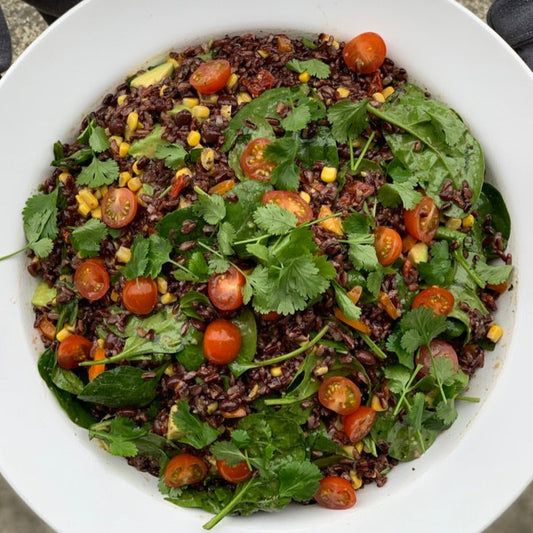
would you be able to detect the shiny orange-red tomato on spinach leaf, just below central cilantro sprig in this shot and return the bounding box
[204,318,242,365]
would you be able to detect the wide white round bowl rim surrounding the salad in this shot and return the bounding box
[0,0,533,533]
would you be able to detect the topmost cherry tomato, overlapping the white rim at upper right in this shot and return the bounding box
[342,31,387,74]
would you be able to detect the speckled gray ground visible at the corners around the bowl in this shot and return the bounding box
[0,0,533,533]
